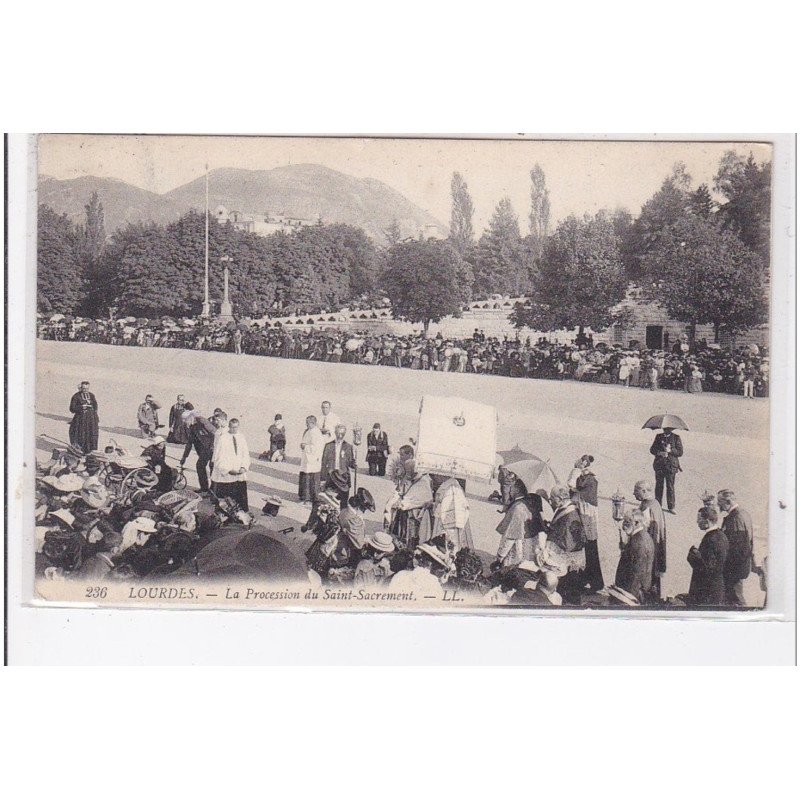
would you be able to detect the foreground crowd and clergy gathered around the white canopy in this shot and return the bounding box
[35,382,766,608]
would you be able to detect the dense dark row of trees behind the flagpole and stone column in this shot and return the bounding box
[38,197,377,317]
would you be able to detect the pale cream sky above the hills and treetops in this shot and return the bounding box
[39,134,772,233]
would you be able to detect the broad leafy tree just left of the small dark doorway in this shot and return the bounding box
[512,211,628,332]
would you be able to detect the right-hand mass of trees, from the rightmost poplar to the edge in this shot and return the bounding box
[504,151,771,335]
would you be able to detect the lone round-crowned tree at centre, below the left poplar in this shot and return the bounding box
[383,239,469,335]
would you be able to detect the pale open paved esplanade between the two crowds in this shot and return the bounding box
[35,341,769,604]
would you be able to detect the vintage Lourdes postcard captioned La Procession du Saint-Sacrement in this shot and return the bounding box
[26,135,788,614]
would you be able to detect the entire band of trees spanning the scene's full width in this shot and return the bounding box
[38,152,771,340]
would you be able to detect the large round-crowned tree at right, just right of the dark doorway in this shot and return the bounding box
[643,217,768,338]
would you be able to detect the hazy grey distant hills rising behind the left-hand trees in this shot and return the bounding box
[39,164,447,243]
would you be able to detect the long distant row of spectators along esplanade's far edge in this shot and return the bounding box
[38,314,769,397]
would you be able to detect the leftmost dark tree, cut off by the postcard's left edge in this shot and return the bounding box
[36,205,84,314]
